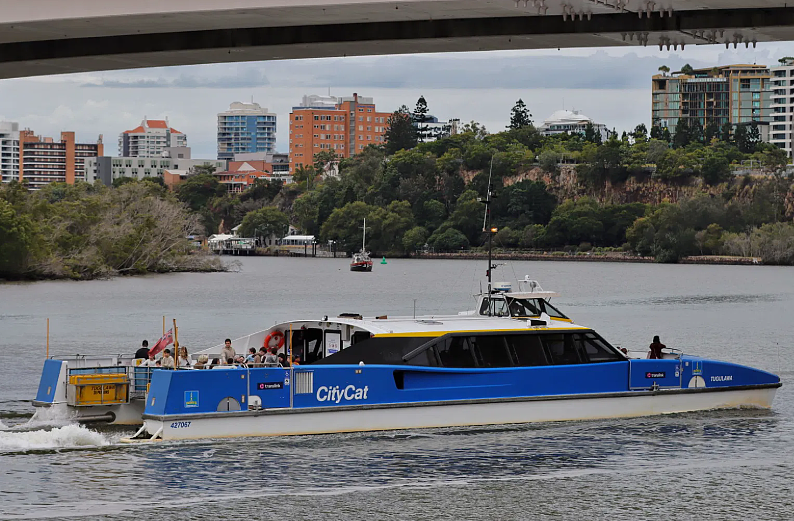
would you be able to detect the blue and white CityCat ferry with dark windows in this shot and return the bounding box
[36,280,781,440]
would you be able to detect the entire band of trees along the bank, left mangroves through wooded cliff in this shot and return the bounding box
[0,100,794,278]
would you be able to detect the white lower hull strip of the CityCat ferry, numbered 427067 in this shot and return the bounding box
[144,387,777,440]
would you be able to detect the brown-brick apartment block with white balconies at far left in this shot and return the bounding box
[19,130,104,190]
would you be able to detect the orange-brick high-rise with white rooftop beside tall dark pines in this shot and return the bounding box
[289,93,391,172]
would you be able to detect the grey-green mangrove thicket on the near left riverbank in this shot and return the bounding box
[0,182,225,279]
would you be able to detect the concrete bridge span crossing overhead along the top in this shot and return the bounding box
[0,0,794,78]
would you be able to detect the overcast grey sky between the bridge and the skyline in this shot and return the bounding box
[0,43,794,158]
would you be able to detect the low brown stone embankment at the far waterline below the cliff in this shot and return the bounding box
[414,251,761,265]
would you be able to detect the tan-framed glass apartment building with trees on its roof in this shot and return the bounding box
[651,65,773,134]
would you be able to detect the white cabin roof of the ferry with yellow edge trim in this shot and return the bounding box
[276,315,590,337]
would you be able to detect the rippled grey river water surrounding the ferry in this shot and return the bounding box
[0,257,794,520]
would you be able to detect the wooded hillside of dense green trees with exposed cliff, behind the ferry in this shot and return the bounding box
[169,99,794,264]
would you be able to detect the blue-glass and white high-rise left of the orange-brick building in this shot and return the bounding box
[218,101,276,161]
